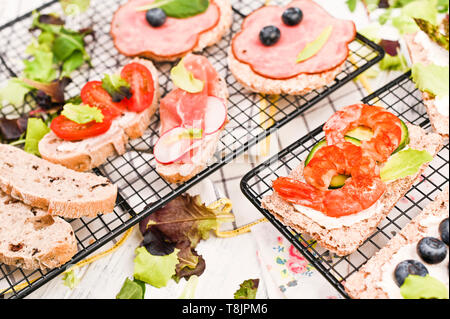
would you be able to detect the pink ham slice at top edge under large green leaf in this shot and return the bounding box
[111,0,220,57]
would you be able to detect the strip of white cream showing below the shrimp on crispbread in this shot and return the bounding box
[294,200,383,229]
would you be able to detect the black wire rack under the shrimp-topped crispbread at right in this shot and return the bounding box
[241,72,449,298]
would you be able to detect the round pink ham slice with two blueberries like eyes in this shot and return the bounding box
[232,0,356,80]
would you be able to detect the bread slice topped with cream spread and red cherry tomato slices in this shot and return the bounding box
[39,59,159,172]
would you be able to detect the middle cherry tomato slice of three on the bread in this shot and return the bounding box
[80,81,126,118]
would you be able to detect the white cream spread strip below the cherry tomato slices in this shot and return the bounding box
[56,112,138,152]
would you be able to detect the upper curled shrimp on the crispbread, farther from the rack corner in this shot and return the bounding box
[323,104,402,162]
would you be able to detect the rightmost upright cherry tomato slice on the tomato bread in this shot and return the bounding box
[120,62,155,113]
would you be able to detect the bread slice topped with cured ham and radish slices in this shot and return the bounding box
[153,54,228,183]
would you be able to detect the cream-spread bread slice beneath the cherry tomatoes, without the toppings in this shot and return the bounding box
[39,59,160,172]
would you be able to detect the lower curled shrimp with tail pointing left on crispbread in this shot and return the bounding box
[273,142,386,217]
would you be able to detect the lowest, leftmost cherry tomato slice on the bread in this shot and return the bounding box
[50,114,112,141]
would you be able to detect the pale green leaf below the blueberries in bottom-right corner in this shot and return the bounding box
[400,275,449,299]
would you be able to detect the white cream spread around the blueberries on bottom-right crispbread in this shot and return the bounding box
[377,216,449,299]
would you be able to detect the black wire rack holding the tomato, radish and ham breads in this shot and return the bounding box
[0,0,384,298]
